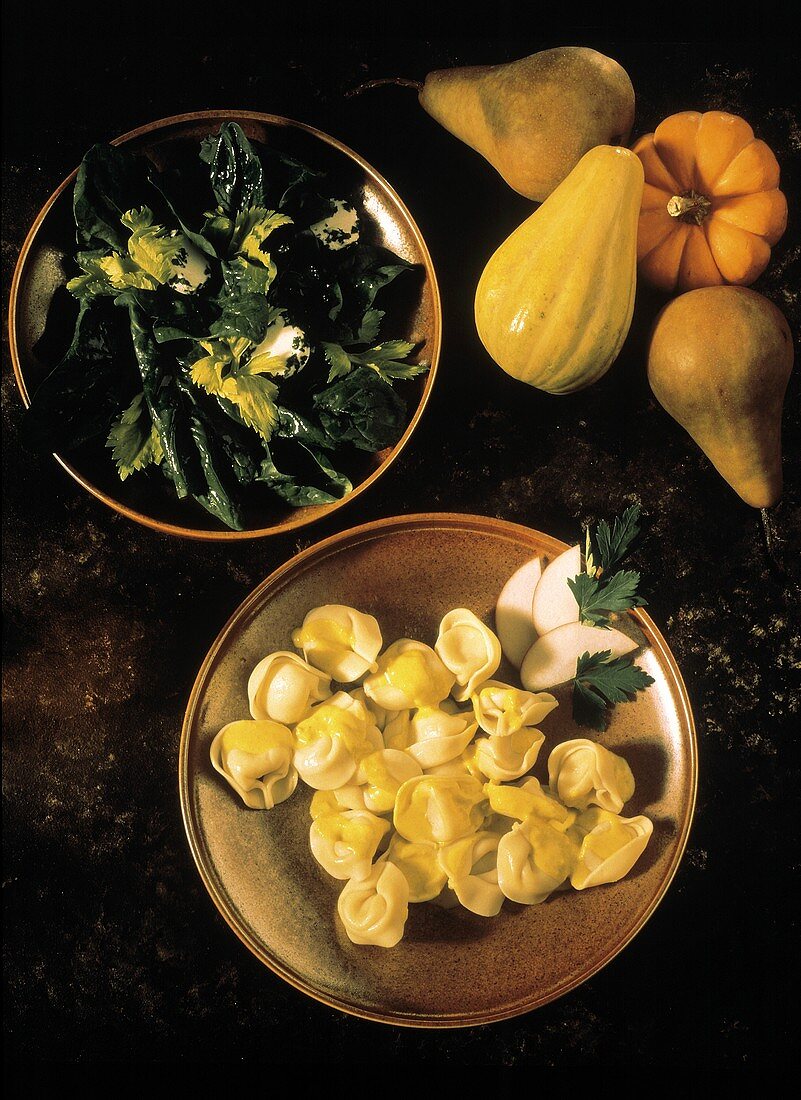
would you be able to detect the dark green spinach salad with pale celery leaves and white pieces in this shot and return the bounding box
[26,122,428,530]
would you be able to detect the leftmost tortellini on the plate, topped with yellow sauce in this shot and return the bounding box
[210,719,297,810]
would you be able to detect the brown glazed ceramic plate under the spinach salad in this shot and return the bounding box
[9,111,441,539]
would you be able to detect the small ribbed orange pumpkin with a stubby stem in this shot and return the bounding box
[634,111,787,292]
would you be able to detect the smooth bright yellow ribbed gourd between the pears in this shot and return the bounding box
[475,145,643,394]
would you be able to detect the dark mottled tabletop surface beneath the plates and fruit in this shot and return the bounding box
[2,6,801,1076]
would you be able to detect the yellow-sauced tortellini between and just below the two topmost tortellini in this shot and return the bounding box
[364,638,456,711]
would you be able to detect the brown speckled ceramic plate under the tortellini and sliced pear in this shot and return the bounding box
[179,515,696,1027]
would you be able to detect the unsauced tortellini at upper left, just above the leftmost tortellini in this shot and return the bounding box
[248,650,331,726]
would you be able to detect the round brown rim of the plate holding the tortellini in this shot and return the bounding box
[178,513,699,1029]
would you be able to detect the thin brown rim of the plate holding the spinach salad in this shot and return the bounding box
[8,109,442,542]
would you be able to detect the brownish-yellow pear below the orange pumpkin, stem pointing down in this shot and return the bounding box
[648,286,794,508]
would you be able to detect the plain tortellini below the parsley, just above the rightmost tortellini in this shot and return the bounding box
[548,737,634,814]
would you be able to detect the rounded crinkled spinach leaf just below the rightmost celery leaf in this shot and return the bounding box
[314,366,406,453]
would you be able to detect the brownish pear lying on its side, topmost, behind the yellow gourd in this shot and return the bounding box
[419,46,634,202]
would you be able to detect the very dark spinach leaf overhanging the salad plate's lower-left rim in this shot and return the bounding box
[23,298,139,452]
